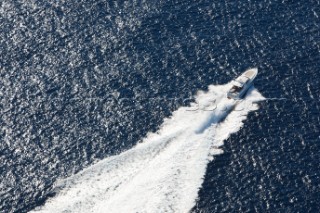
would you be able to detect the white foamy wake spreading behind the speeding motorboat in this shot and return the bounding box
[32,84,263,213]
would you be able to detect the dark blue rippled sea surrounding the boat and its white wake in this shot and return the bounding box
[0,0,320,212]
